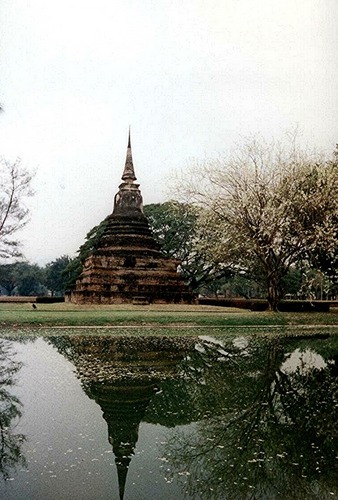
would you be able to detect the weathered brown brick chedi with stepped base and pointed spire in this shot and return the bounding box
[66,134,192,304]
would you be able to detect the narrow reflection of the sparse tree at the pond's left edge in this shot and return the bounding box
[0,339,26,480]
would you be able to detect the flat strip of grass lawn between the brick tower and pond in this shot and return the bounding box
[0,303,338,334]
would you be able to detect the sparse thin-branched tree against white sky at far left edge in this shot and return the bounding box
[0,158,32,258]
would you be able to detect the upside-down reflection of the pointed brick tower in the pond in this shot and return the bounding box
[51,336,193,500]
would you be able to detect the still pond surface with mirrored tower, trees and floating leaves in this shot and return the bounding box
[0,330,338,500]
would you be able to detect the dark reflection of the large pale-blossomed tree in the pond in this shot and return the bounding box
[160,340,338,500]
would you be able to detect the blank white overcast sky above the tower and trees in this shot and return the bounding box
[0,0,338,264]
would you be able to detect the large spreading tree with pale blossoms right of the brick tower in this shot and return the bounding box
[180,140,338,311]
